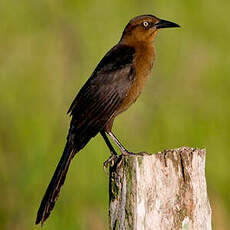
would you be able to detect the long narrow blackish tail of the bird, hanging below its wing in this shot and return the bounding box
[35,141,76,225]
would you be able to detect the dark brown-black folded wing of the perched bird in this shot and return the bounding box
[68,45,135,151]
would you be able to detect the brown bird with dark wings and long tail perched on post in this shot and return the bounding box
[35,14,180,225]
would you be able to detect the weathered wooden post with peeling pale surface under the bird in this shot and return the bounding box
[109,147,211,230]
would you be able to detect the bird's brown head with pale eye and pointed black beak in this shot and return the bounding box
[121,15,180,43]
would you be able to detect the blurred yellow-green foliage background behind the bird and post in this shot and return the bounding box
[0,0,230,230]
